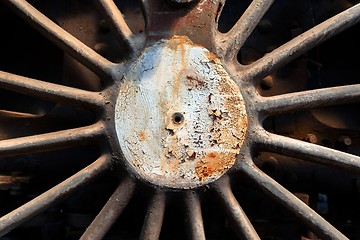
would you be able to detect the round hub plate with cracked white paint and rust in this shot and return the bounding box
[115,37,247,188]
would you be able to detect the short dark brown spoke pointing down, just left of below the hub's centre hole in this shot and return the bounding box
[139,190,166,240]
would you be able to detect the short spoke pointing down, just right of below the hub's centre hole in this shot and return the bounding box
[185,191,206,240]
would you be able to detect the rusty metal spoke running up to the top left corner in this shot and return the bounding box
[4,0,116,77]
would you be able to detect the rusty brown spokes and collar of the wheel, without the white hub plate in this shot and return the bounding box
[0,0,360,239]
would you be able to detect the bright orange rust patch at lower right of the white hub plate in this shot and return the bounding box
[195,152,236,181]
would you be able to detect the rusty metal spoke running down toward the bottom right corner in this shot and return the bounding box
[241,161,347,239]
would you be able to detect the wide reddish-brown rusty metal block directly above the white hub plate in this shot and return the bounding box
[143,0,224,51]
